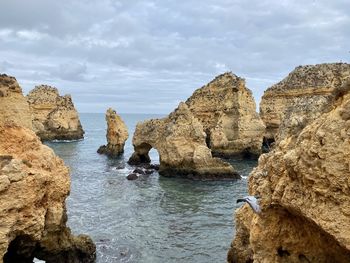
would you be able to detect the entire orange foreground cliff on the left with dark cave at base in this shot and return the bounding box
[0,75,95,263]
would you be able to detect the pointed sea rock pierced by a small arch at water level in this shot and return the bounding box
[129,102,240,180]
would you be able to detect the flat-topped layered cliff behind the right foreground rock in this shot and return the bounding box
[260,63,350,141]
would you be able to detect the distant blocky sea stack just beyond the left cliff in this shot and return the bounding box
[27,85,84,140]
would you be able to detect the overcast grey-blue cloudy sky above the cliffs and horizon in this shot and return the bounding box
[0,0,350,113]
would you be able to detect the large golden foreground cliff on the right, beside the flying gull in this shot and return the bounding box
[228,80,350,262]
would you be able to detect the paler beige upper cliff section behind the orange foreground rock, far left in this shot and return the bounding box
[0,74,32,129]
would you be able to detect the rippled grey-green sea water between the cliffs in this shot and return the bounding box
[47,114,256,263]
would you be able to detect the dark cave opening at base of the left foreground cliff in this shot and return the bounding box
[3,235,37,263]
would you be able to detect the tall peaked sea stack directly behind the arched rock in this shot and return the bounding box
[186,72,265,157]
